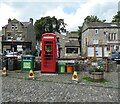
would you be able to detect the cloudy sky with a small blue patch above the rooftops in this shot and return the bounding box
[0,0,119,31]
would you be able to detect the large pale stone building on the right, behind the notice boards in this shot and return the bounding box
[81,22,120,56]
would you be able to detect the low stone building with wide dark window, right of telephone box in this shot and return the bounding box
[55,32,80,58]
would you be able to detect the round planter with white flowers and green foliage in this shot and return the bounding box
[89,65,104,80]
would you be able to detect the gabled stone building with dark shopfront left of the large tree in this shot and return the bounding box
[2,18,36,52]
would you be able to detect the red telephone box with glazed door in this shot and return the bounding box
[41,33,57,72]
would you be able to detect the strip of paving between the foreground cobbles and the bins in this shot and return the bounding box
[2,71,119,88]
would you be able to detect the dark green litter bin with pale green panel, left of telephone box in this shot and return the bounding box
[21,55,35,71]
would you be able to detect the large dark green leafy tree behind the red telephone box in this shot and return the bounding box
[34,16,67,40]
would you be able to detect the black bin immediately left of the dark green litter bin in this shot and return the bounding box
[7,56,17,70]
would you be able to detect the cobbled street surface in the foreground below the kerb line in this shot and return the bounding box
[2,77,118,102]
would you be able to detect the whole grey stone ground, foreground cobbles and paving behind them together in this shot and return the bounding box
[0,65,120,104]
